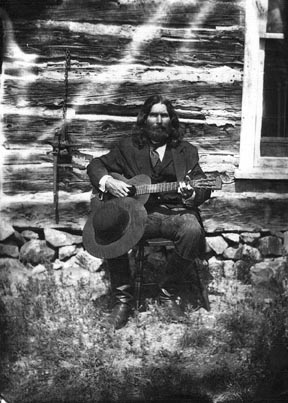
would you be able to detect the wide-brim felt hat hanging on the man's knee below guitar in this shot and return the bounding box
[83,197,147,259]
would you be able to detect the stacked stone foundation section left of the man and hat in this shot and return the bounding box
[0,223,108,298]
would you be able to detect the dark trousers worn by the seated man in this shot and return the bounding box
[108,209,205,289]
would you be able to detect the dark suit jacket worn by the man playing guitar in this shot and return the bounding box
[87,137,211,208]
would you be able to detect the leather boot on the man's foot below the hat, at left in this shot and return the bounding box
[102,285,133,330]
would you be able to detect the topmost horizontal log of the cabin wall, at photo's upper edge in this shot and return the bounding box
[6,0,243,26]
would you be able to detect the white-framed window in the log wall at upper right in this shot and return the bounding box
[235,0,288,180]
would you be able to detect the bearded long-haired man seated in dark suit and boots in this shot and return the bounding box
[87,95,211,329]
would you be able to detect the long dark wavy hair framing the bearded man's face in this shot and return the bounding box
[132,95,182,148]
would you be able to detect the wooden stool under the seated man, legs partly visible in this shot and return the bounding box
[135,238,210,311]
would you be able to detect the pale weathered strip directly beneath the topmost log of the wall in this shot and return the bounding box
[10,19,244,42]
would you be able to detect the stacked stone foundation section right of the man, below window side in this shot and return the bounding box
[206,231,288,292]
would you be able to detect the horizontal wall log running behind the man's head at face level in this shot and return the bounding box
[3,115,240,154]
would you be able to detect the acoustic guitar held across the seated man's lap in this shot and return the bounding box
[93,172,222,205]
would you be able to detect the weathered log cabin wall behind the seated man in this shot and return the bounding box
[1,0,288,231]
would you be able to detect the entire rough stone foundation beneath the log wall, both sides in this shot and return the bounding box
[0,223,288,298]
